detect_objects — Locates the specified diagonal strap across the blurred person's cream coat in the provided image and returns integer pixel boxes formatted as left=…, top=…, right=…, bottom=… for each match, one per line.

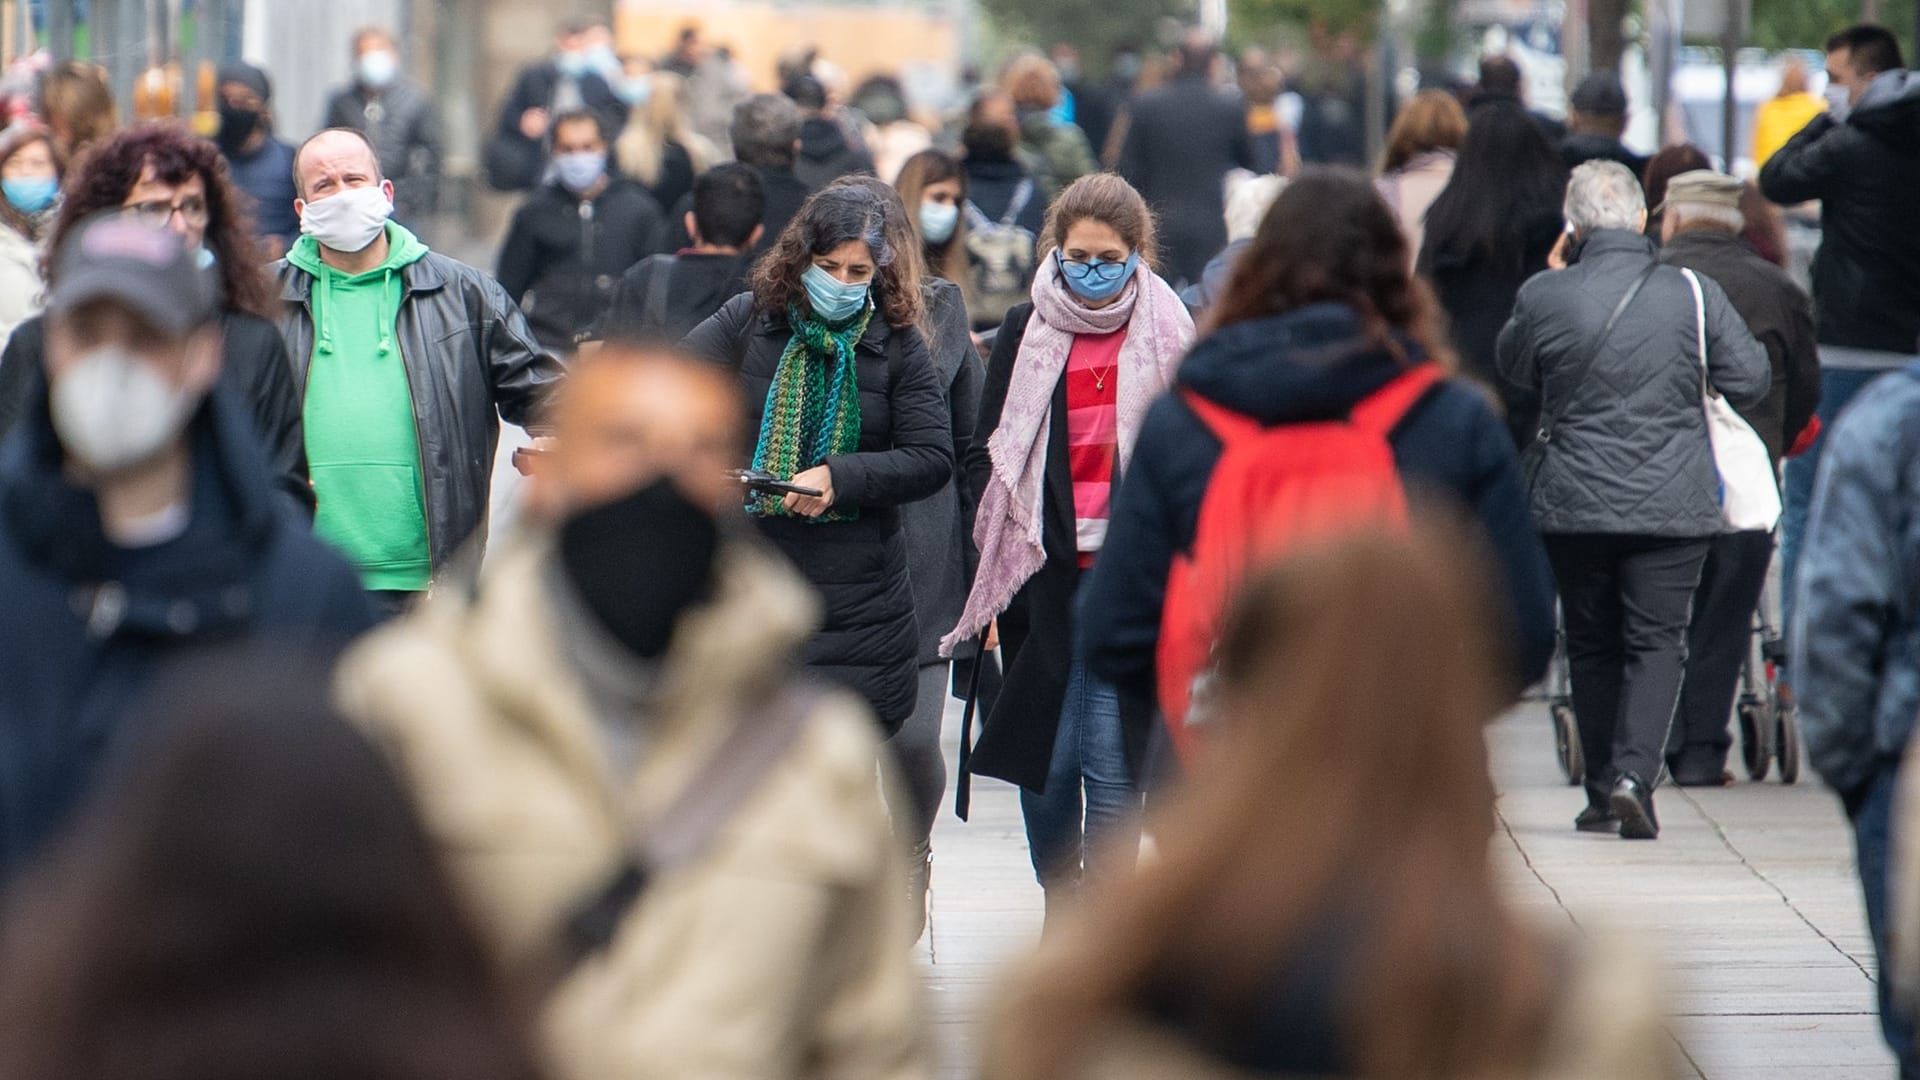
left=559, top=684, right=820, bottom=974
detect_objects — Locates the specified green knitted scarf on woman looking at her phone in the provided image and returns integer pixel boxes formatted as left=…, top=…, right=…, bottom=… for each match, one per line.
left=747, top=306, right=874, bottom=521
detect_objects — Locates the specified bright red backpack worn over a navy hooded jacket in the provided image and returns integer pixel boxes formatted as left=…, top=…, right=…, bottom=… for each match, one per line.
left=1158, top=363, right=1442, bottom=755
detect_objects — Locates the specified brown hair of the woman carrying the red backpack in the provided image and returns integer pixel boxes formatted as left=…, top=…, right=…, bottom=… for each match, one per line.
left=1210, top=165, right=1453, bottom=367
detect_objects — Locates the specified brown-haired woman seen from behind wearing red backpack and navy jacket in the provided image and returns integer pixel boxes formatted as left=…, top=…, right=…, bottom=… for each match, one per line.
left=1077, top=165, right=1553, bottom=757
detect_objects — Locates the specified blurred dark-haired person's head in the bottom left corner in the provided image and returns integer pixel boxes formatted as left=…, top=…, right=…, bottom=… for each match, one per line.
left=0, top=651, right=540, bottom=1080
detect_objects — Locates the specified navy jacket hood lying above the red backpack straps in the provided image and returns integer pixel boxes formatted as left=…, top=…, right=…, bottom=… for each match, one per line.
left=1179, top=304, right=1425, bottom=425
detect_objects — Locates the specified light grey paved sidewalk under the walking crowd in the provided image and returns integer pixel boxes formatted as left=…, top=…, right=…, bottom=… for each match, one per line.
left=920, top=703, right=1895, bottom=1080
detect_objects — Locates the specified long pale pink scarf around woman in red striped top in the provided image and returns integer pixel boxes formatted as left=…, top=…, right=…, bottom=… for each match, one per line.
left=941, top=258, right=1194, bottom=655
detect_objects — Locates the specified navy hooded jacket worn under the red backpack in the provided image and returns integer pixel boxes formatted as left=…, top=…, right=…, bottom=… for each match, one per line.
left=1075, top=304, right=1553, bottom=714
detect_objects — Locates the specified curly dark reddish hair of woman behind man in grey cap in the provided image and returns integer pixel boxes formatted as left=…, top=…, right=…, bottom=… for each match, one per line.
left=46, top=121, right=273, bottom=319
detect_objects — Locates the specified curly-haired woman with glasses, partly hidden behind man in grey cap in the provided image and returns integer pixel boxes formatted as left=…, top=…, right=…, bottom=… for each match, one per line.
left=0, top=121, right=313, bottom=517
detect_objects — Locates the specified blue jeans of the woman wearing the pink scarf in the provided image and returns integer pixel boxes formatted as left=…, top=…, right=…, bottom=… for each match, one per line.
left=1020, top=661, right=1140, bottom=888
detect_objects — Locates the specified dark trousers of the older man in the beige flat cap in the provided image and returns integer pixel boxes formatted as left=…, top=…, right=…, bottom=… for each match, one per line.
left=1667, top=532, right=1774, bottom=782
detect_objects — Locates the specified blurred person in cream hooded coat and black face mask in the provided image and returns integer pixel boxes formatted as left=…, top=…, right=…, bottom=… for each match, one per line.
left=340, top=346, right=925, bottom=1080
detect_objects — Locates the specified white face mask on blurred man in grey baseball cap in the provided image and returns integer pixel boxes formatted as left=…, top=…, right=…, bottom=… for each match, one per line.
left=50, top=346, right=196, bottom=473
